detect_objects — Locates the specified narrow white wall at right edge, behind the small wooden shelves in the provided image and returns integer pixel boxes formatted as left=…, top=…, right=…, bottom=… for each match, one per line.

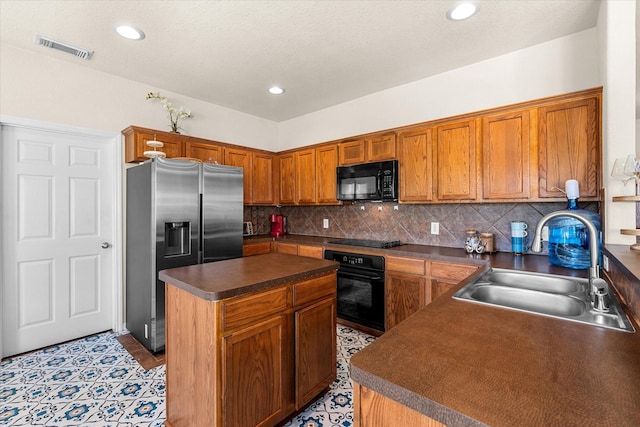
left=597, top=1, right=636, bottom=244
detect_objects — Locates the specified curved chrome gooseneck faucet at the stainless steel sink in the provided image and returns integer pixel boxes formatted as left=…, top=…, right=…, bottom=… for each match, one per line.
left=531, top=210, right=609, bottom=311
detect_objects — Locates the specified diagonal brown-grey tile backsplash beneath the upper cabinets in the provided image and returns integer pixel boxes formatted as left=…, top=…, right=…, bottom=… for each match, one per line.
left=244, top=202, right=599, bottom=252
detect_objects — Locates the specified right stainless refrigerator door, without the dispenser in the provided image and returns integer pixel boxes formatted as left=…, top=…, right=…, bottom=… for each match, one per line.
left=201, top=163, right=243, bottom=262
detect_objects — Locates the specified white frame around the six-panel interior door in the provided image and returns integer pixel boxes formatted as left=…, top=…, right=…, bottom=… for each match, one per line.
left=0, top=114, right=124, bottom=355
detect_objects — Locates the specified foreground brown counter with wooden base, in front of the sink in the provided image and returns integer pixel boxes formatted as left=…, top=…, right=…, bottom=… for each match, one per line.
left=351, top=275, right=640, bottom=427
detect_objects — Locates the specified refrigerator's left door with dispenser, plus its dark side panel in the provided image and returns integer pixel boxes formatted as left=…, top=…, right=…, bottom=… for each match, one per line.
left=126, top=159, right=200, bottom=352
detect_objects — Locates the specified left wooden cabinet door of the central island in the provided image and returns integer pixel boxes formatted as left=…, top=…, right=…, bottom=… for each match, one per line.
left=224, top=315, right=294, bottom=427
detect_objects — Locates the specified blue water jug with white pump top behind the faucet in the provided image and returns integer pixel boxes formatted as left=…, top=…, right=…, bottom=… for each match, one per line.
left=549, top=179, right=602, bottom=270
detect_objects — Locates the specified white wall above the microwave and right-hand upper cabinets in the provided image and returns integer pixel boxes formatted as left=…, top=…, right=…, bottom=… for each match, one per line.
left=279, top=29, right=601, bottom=149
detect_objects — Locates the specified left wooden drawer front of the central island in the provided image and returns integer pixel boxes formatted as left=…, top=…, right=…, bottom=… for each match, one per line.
left=222, top=286, right=287, bottom=330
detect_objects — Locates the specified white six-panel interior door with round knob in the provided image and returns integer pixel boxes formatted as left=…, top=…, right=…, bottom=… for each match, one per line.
left=1, top=126, right=115, bottom=356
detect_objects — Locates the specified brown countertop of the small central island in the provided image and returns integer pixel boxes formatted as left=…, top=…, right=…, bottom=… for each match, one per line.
left=159, top=253, right=338, bottom=301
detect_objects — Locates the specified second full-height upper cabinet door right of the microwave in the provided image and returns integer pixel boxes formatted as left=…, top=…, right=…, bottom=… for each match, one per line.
left=436, top=120, right=477, bottom=200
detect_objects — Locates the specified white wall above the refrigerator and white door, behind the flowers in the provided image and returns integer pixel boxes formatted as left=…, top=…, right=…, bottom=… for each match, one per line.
left=0, top=43, right=278, bottom=151
